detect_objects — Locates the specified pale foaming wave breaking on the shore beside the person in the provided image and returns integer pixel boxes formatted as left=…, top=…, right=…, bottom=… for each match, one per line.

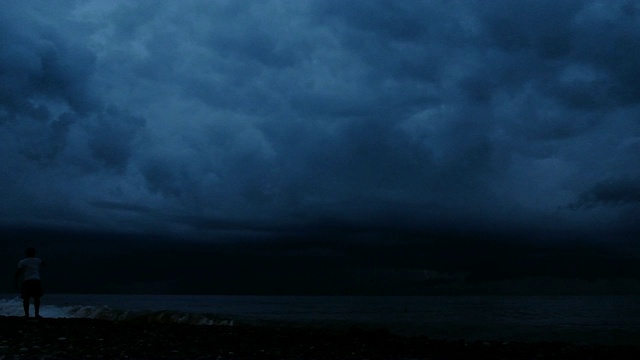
left=0, top=297, right=234, bottom=326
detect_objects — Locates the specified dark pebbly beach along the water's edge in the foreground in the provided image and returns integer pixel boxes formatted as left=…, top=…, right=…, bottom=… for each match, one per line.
left=0, top=317, right=640, bottom=360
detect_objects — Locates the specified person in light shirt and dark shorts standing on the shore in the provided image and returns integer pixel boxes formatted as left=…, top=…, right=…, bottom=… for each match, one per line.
left=15, top=247, right=44, bottom=318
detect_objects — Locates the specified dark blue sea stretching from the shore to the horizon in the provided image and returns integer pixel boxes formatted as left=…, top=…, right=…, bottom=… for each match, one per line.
left=0, top=294, right=640, bottom=346
